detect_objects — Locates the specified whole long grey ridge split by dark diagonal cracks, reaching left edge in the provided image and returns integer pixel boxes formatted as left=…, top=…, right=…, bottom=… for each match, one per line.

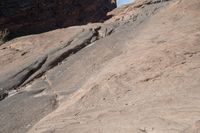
left=0, top=27, right=108, bottom=99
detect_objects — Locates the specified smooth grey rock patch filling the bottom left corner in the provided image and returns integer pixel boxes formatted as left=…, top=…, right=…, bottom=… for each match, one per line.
left=0, top=89, right=57, bottom=133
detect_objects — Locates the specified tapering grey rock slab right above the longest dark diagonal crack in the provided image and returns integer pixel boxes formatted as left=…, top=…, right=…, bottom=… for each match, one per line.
left=22, top=29, right=101, bottom=86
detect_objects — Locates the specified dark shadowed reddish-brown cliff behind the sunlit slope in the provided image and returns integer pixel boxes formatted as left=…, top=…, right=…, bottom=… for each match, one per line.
left=0, top=0, right=116, bottom=41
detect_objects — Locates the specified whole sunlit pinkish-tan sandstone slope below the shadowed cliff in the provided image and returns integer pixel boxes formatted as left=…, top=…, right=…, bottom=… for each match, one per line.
left=0, top=0, right=200, bottom=133
